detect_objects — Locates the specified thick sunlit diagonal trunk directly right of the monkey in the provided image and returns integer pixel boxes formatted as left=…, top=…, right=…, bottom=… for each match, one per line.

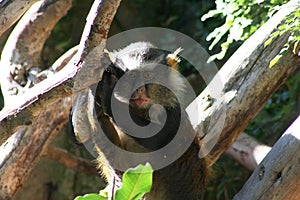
left=188, top=0, right=300, bottom=162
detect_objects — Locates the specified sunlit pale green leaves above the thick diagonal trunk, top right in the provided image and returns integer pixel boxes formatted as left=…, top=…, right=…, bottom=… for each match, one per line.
left=201, top=0, right=287, bottom=61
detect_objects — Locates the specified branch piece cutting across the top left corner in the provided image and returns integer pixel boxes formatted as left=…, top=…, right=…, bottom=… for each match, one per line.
left=0, top=0, right=38, bottom=36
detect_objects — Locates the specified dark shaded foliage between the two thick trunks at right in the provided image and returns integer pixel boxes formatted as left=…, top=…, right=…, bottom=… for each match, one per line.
left=246, top=72, right=300, bottom=146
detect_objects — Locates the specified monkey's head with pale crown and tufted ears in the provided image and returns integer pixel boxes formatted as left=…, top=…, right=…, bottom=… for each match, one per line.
left=107, top=42, right=186, bottom=119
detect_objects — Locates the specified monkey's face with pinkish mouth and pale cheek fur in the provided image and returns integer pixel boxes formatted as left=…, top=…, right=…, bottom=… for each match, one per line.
left=114, top=63, right=184, bottom=110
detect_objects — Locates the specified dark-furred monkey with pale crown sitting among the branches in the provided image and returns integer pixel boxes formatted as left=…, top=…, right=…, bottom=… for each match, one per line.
left=86, top=42, right=210, bottom=200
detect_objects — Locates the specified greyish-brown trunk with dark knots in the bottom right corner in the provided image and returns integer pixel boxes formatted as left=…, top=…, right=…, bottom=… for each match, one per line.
left=234, top=117, right=300, bottom=200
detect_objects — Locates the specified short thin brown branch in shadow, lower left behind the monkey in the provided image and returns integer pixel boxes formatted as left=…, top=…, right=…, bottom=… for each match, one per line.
left=44, top=145, right=98, bottom=174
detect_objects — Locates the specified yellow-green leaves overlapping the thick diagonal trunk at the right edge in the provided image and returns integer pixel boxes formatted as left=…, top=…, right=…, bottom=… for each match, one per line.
left=265, top=10, right=300, bottom=68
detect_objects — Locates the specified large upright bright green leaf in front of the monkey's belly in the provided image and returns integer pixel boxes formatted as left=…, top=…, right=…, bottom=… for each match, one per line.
left=114, top=163, right=153, bottom=200
